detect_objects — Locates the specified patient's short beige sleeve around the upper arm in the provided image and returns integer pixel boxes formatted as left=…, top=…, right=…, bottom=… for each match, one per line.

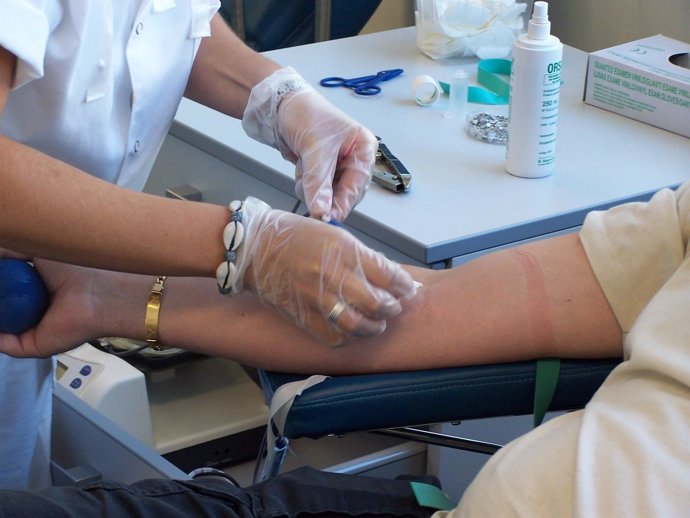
left=580, top=184, right=690, bottom=333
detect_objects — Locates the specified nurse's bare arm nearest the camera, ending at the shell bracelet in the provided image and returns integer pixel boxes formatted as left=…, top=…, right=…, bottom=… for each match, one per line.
left=0, top=47, right=228, bottom=277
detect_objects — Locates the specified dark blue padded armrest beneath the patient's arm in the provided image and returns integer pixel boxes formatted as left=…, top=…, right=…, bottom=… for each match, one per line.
left=259, top=358, right=621, bottom=438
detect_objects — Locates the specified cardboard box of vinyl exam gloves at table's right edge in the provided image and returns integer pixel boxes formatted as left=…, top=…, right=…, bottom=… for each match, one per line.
left=584, top=35, right=690, bottom=137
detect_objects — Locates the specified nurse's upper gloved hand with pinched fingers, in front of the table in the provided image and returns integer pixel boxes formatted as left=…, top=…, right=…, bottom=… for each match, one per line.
left=242, top=67, right=378, bottom=221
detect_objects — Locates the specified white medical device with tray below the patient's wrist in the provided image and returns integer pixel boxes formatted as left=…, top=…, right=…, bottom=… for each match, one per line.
left=56, top=344, right=268, bottom=471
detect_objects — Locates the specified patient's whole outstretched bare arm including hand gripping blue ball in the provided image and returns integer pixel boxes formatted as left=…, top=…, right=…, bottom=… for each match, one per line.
left=0, top=234, right=622, bottom=374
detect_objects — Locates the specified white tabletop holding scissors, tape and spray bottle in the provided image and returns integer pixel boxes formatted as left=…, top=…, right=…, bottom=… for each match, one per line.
left=172, top=27, right=690, bottom=263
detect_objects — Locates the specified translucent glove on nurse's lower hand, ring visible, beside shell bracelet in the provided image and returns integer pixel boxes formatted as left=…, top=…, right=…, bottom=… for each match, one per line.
left=226, top=198, right=416, bottom=345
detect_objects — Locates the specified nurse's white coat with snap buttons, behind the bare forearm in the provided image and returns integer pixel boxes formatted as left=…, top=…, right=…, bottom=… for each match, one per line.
left=0, top=0, right=220, bottom=487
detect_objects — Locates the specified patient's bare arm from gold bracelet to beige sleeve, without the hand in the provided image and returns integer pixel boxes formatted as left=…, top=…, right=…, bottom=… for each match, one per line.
left=155, top=234, right=622, bottom=374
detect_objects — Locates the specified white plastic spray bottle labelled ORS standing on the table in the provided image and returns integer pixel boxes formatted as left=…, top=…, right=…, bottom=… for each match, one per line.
left=505, top=1, right=563, bottom=178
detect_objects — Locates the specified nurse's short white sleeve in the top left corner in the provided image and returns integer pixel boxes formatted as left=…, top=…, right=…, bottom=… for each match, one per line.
left=0, top=0, right=50, bottom=88
